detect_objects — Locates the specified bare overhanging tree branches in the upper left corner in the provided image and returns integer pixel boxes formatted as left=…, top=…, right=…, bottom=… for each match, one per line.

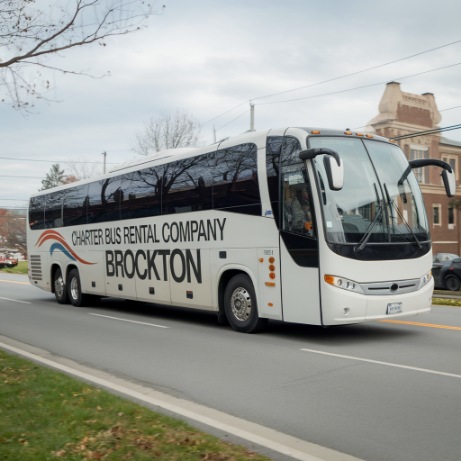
left=0, top=0, right=164, bottom=109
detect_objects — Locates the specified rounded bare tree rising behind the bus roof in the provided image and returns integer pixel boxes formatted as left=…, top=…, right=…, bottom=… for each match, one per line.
left=133, top=109, right=200, bottom=155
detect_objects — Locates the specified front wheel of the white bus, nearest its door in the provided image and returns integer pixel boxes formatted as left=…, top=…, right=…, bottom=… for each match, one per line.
left=224, top=274, right=267, bottom=333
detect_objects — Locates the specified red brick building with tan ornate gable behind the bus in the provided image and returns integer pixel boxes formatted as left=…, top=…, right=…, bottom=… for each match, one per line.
left=367, top=82, right=461, bottom=255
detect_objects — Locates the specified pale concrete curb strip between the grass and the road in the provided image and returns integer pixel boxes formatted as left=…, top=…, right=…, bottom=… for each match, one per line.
left=0, top=336, right=361, bottom=461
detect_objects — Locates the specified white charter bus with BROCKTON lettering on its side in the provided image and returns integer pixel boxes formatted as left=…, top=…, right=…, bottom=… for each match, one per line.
left=28, top=128, right=455, bottom=333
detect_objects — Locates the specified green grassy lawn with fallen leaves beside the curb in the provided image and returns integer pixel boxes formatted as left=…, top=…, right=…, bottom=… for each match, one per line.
left=0, top=350, right=268, bottom=461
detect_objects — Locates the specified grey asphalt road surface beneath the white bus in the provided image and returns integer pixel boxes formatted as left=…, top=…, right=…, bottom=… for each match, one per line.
left=0, top=273, right=461, bottom=461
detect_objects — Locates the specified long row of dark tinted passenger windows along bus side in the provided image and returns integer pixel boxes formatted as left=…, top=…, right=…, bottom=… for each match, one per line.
left=29, top=144, right=261, bottom=225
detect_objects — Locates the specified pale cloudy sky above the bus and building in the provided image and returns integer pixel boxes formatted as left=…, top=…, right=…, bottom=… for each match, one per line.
left=0, top=0, right=461, bottom=208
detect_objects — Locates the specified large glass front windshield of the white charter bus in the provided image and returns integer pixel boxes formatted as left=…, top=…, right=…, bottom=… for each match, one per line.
left=308, top=137, right=429, bottom=259
